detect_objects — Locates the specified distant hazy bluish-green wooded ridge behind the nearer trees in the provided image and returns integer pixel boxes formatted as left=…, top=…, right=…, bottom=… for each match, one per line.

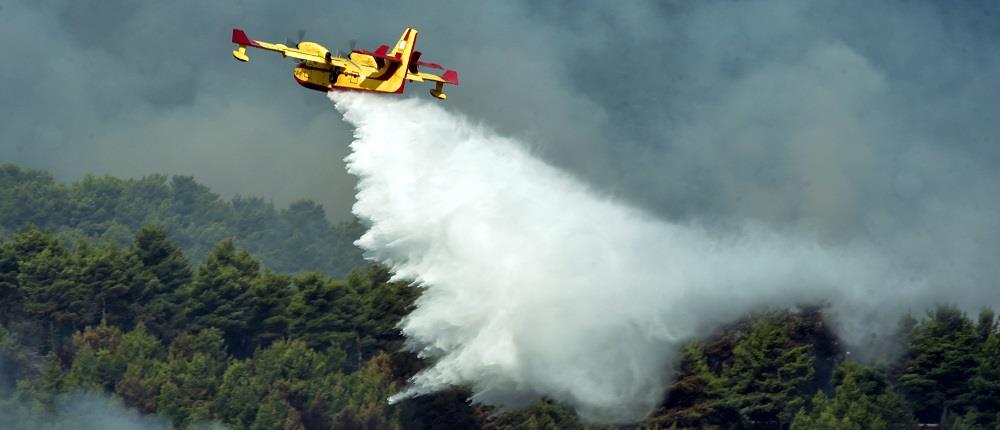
left=0, top=164, right=364, bottom=278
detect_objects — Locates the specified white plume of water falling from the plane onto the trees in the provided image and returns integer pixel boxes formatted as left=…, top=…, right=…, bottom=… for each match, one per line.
left=331, top=93, right=912, bottom=422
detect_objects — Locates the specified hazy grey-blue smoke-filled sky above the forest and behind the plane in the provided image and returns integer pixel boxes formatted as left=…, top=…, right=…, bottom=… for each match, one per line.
left=0, top=0, right=1000, bottom=302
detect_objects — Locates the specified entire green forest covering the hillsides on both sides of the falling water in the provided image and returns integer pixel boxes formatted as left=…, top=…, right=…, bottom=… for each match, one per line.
left=0, top=166, right=1000, bottom=430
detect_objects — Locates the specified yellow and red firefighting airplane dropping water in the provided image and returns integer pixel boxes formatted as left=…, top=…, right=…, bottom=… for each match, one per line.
left=233, top=28, right=458, bottom=100
